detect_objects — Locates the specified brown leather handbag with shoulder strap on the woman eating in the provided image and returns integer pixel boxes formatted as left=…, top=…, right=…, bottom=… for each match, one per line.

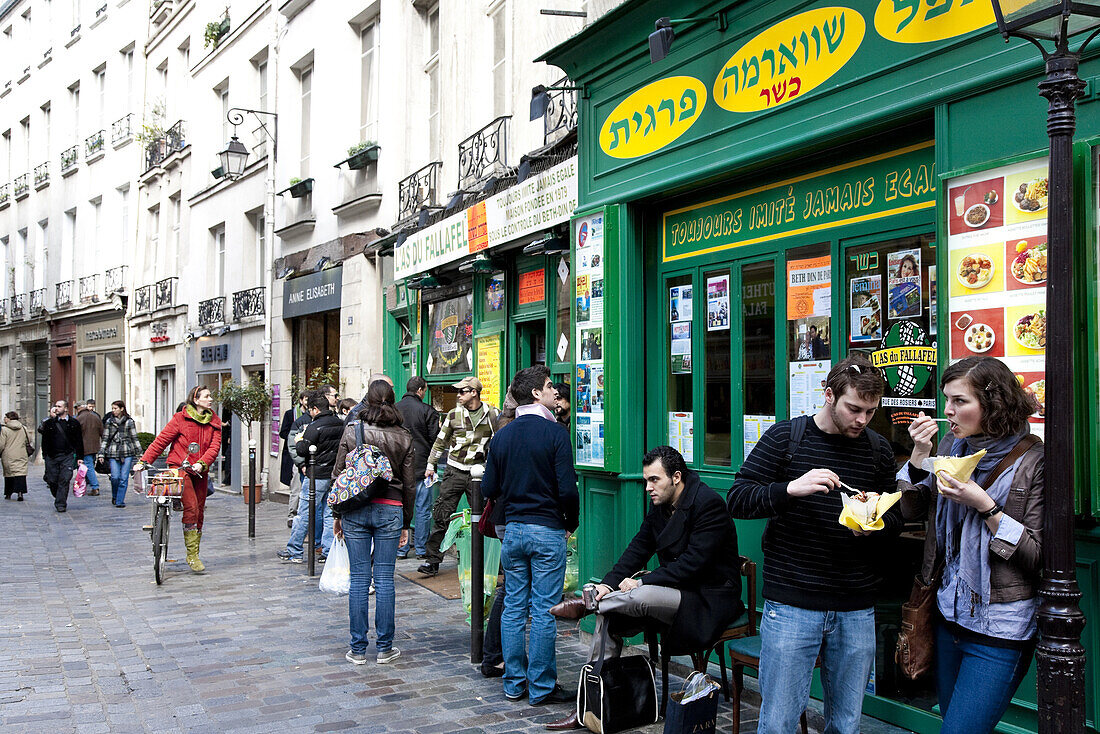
left=894, top=435, right=1038, bottom=680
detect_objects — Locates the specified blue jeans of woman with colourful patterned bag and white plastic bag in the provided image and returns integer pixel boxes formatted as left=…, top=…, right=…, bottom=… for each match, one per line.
left=340, top=504, right=403, bottom=655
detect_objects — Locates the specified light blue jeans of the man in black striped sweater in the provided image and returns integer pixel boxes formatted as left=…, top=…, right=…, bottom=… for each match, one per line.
left=757, top=601, right=875, bottom=734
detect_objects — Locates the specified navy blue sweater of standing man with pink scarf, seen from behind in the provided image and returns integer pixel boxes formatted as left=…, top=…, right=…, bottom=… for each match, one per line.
left=481, top=415, right=580, bottom=533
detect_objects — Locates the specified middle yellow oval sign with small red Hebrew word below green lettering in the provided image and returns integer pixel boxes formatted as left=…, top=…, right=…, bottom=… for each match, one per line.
left=714, top=8, right=867, bottom=112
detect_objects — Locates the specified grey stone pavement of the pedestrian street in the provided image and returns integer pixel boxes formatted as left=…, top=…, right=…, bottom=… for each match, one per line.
left=0, top=467, right=901, bottom=734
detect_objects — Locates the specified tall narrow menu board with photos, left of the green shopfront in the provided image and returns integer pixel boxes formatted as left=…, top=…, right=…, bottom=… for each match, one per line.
left=573, top=213, right=604, bottom=467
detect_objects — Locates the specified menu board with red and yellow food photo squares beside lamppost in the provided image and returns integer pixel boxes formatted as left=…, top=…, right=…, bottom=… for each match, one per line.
left=943, top=158, right=1048, bottom=436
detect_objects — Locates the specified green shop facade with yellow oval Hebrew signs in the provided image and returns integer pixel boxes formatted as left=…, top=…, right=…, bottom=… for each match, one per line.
left=541, top=0, right=1100, bottom=732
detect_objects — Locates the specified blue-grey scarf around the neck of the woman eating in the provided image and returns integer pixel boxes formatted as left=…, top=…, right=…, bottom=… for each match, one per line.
left=933, top=426, right=1029, bottom=604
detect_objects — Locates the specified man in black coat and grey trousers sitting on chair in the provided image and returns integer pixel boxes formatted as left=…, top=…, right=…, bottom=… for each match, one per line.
left=547, top=446, right=745, bottom=731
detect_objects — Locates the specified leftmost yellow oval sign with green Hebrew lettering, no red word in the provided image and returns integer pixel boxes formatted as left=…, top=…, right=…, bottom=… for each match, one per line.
left=600, top=76, right=706, bottom=158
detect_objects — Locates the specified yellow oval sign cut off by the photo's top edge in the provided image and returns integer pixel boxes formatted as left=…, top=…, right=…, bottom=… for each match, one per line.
left=875, top=0, right=997, bottom=43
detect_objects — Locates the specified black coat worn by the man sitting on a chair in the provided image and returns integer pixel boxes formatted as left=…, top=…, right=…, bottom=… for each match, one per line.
left=603, top=470, right=745, bottom=655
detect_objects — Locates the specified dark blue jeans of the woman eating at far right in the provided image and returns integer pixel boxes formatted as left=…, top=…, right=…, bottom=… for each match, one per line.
left=936, top=624, right=1035, bottom=734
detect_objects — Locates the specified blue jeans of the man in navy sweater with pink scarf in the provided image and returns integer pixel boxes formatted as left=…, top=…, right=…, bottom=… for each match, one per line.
left=501, top=523, right=565, bottom=703
